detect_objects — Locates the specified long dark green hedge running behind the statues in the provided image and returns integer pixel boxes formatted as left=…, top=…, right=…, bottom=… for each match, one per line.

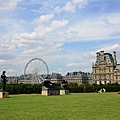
left=3, top=83, right=120, bottom=94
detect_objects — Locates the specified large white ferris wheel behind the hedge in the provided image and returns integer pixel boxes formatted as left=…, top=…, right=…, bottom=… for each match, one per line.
left=24, top=58, right=49, bottom=83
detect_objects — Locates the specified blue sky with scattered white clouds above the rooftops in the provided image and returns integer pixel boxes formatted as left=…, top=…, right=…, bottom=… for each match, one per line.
left=0, top=0, right=120, bottom=76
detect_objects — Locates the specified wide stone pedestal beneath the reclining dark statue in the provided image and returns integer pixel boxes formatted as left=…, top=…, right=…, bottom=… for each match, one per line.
left=42, top=89, right=60, bottom=96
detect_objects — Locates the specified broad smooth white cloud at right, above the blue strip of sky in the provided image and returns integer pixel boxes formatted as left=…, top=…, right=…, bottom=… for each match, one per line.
left=63, top=13, right=120, bottom=41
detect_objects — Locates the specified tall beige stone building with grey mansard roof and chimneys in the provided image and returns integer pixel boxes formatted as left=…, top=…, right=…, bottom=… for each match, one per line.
left=92, top=51, right=120, bottom=84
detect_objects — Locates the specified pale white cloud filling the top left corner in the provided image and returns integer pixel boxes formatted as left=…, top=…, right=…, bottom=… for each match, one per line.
left=0, top=0, right=22, bottom=11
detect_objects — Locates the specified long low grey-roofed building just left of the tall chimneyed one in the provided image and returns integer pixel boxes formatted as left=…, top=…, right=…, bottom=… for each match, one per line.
left=63, top=71, right=92, bottom=84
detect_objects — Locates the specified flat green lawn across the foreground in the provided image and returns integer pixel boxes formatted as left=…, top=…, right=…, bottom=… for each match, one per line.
left=0, top=93, right=120, bottom=120
